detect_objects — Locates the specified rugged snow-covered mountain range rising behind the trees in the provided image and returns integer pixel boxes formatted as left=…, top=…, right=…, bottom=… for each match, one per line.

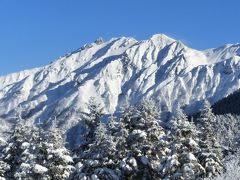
left=0, top=34, right=240, bottom=126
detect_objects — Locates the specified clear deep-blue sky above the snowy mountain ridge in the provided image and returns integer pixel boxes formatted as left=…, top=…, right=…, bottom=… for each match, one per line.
left=0, top=0, right=240, bottom=75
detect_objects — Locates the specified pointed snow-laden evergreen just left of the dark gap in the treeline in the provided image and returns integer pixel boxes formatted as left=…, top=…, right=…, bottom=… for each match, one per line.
left=37, top=119, right=75, bottom=180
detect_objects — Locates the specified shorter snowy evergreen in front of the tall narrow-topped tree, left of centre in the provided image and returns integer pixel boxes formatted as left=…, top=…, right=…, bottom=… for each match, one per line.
left=75, top=122, right=119, bottom=179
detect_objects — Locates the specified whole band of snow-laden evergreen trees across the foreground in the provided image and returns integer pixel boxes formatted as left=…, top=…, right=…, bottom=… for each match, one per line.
left=0, top=98, right=240, bottom=180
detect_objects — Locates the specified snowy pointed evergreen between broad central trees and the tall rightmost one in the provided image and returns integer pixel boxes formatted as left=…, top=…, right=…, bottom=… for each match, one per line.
left=160, top=108, right=205, bottom=179
